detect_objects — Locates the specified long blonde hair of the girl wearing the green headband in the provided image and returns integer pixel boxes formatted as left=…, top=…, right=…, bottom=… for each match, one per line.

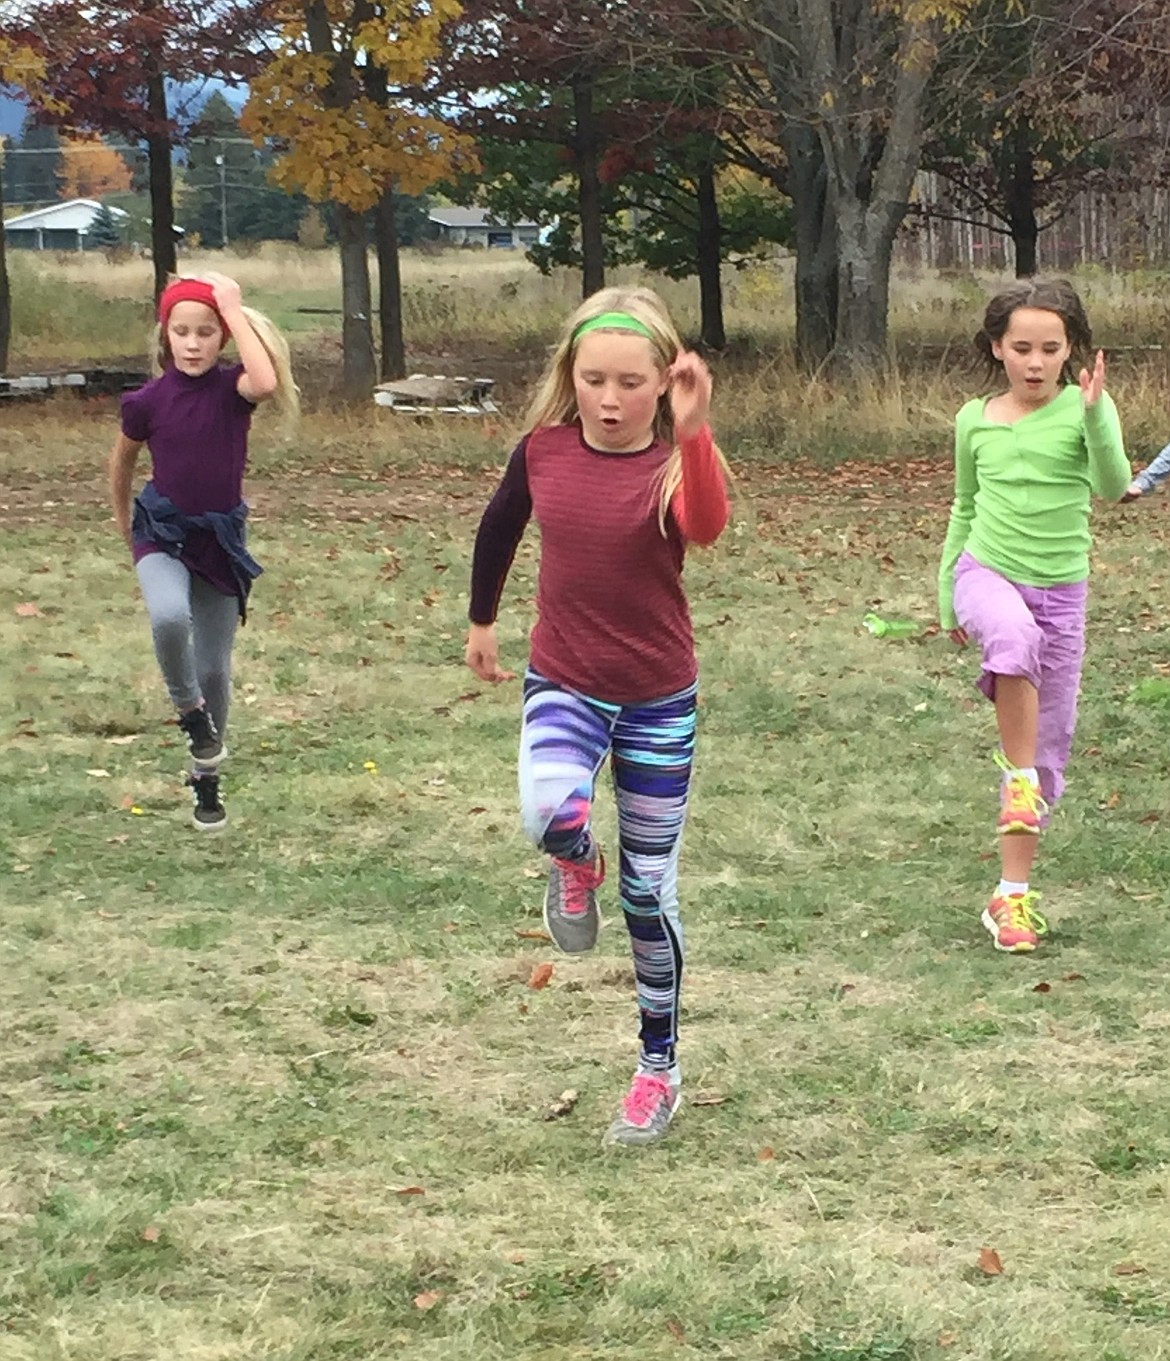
left=524, top=287, right=728, bottom=535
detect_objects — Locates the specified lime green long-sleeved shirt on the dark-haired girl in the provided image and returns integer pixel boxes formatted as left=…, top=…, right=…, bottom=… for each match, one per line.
left=939, top=384, right=1131, bottom=630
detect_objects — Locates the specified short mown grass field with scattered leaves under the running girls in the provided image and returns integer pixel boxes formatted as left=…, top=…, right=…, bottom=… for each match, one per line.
left=0, top=257, right=1170, bottom=1361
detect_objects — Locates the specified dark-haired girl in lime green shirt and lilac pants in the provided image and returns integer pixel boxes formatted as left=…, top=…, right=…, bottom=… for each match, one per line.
left=939, top=279, right=1131, bottom=953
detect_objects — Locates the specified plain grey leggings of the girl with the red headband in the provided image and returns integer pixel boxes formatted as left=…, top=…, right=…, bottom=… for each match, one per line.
left=137, top=553, right=239, bottom=736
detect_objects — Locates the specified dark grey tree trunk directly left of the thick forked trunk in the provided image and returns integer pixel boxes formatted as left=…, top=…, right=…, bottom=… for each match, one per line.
left=780, top=121, right=838, bottom=372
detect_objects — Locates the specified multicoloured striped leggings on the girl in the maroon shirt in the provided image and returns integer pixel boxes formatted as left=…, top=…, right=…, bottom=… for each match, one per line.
left=520, top=670, right=697, bottom=1071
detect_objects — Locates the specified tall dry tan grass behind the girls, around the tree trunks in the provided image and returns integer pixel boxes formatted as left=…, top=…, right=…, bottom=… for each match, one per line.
left=11, top=242, right=1170, bottom=465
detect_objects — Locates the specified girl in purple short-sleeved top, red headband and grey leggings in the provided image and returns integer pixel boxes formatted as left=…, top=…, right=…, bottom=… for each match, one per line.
left=110, top=274, right=297, bottom=832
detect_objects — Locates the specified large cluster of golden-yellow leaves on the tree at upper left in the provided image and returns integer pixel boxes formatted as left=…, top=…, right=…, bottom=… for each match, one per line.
left=241, top=0, right=475, bottom=212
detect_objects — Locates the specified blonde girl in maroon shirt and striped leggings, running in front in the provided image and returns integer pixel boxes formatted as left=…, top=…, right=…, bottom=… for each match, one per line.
left=467, top=289, right=728, bottom=1145
